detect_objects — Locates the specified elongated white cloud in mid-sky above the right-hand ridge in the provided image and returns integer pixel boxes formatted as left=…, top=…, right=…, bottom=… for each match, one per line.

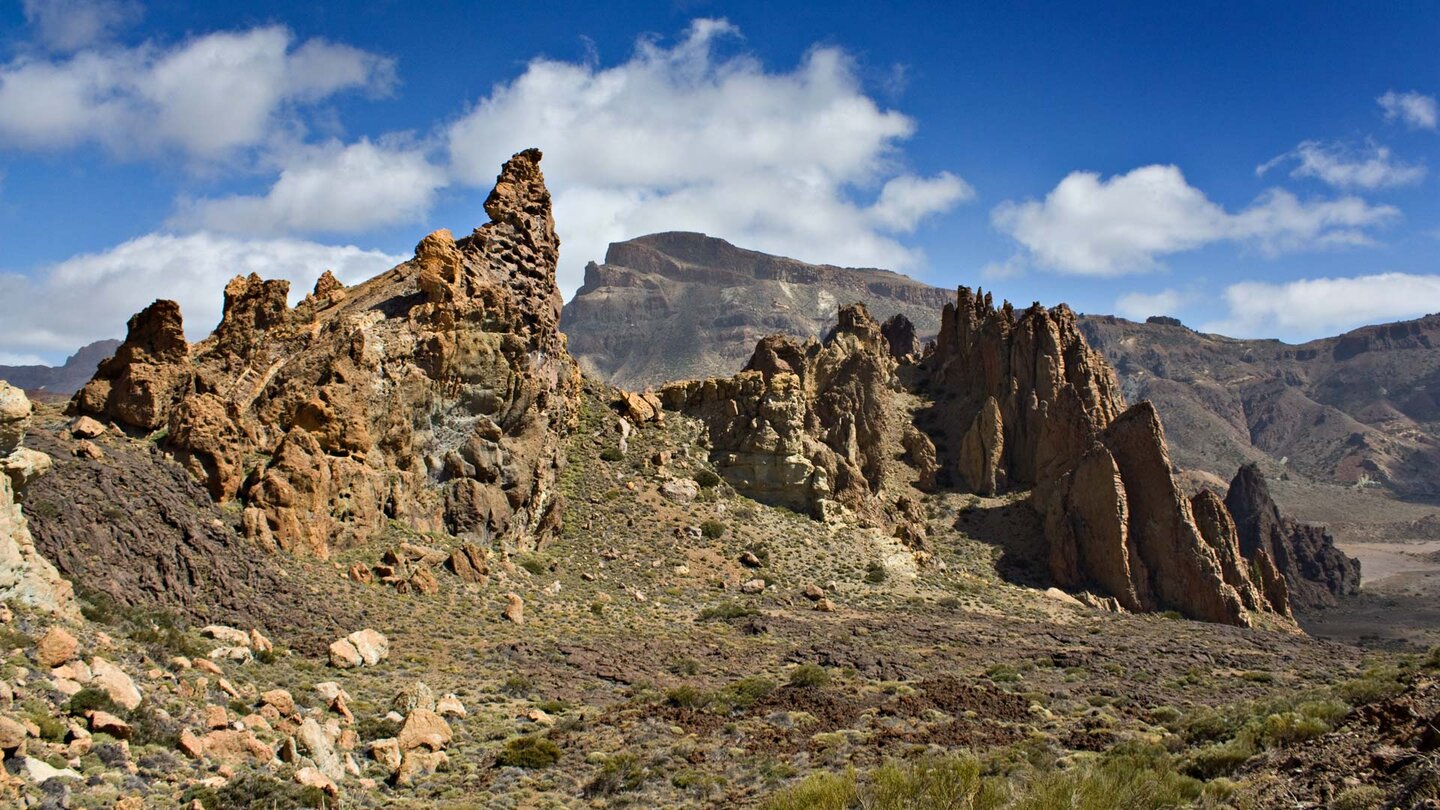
left=991, top=164, right=1400, bottom=275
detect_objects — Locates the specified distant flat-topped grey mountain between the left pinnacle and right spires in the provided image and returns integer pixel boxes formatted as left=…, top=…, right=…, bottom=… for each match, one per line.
left=563, top=232, right=950, bottom=391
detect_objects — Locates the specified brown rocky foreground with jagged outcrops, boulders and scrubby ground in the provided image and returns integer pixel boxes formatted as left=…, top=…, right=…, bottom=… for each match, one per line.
left=0, top=151, right=1440, bottom=810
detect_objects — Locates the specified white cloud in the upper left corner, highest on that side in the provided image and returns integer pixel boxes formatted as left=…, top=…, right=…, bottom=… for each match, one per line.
left=0, top=26, right=395, bottom=160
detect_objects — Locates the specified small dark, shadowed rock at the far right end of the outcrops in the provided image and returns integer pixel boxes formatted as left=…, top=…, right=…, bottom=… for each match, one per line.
left=1225, top=464, right=1359, bottom=608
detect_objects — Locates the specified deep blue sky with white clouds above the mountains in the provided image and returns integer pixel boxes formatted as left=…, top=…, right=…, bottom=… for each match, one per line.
left=0, top=0, right=1440, bottom=363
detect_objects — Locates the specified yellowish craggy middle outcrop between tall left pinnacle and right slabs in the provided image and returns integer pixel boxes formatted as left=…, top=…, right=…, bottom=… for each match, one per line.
left=660, top=304, right=913, bottom=539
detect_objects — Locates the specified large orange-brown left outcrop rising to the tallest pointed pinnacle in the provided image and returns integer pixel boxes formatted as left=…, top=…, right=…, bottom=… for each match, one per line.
left=72, top=150, right=579, bottom=556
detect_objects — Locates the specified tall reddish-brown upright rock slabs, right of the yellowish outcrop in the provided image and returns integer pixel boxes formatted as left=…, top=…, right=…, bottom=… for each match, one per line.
left=920, top=287, right=1284, bottom=624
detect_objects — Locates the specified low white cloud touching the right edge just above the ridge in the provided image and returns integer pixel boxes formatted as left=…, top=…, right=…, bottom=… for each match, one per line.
left=1202, top=272, right=1440, bottom=337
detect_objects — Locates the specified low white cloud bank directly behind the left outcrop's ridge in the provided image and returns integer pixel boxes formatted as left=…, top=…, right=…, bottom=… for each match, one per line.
left=0, top=233, right=409, bottom=360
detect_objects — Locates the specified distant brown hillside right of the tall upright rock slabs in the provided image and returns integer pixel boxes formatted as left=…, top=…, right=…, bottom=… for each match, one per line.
left=1081, top=309, right=1440, bottom=502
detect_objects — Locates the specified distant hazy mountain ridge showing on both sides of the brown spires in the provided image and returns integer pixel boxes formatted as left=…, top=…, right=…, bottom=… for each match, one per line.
left=562, top=233, right=1440, bottom=500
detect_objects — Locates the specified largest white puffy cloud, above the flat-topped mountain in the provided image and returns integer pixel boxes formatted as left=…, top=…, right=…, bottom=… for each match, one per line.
left=446, top=20, right=973, bottom=293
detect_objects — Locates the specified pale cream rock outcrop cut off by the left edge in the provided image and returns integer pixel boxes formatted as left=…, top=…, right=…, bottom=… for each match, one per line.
left=0, top=380, right=79, bottom=618
